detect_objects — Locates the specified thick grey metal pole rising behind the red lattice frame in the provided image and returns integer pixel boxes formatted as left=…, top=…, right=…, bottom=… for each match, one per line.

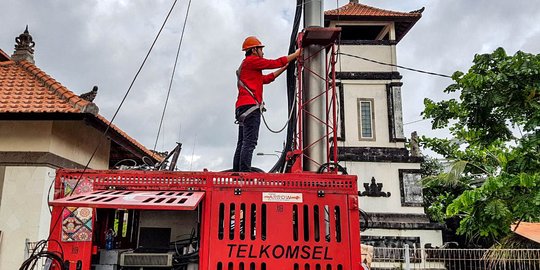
left=302, top=0, right=326, bottom=172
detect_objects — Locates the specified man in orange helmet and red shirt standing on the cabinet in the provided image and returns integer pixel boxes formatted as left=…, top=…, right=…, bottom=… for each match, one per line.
left=233, top=37, right=300, bottom=172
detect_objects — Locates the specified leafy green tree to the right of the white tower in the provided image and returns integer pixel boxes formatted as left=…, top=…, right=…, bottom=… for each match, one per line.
left=421, top=48, right=540, bottom=244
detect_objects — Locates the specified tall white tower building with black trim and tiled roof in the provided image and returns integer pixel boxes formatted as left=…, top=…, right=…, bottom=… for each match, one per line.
left=325, top=0, right=442, bottom=247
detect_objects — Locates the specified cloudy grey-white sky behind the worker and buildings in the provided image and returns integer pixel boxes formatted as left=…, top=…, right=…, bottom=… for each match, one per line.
left=0, top=0, right=540, bottom=171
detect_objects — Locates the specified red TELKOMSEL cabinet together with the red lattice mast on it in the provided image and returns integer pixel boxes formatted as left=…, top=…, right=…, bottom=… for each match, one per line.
left=45, top=25, right=362, bottom=270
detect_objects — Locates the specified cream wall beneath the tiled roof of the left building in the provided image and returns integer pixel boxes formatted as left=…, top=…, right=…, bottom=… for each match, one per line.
left=0, top=121, right=110, bottom=269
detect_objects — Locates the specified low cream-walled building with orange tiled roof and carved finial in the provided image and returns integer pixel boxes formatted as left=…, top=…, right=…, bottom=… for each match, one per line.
left=0, top=29, right=160, bottom=270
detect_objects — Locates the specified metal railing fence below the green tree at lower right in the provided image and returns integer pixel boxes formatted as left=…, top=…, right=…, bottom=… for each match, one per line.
left=370, top=245, right=540, bottom=270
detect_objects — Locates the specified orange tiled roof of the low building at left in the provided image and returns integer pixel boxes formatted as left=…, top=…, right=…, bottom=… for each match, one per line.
left=0, top=56, right=162, bottom=163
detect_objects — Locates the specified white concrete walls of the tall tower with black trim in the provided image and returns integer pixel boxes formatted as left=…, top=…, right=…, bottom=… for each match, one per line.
left=329, top=14, right=442, bottom=249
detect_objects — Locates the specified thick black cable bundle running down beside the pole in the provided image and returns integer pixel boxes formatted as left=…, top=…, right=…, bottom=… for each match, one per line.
left=270, top=0, right=304, bottom=173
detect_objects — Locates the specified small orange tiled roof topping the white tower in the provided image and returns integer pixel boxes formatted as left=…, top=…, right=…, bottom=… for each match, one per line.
left=324, top=3, right=423, bottom=19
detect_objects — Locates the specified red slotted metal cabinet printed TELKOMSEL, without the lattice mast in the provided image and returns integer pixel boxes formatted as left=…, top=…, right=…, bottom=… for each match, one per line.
left=45, top=170, right=361, bottom=270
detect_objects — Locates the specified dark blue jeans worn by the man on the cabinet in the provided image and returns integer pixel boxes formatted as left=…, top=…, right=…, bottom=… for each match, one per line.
left=233, top=105, right=261, bottom=172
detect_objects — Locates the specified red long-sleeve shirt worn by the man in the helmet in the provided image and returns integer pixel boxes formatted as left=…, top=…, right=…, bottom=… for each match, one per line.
left=236, top=55, right=287, bottom=108
